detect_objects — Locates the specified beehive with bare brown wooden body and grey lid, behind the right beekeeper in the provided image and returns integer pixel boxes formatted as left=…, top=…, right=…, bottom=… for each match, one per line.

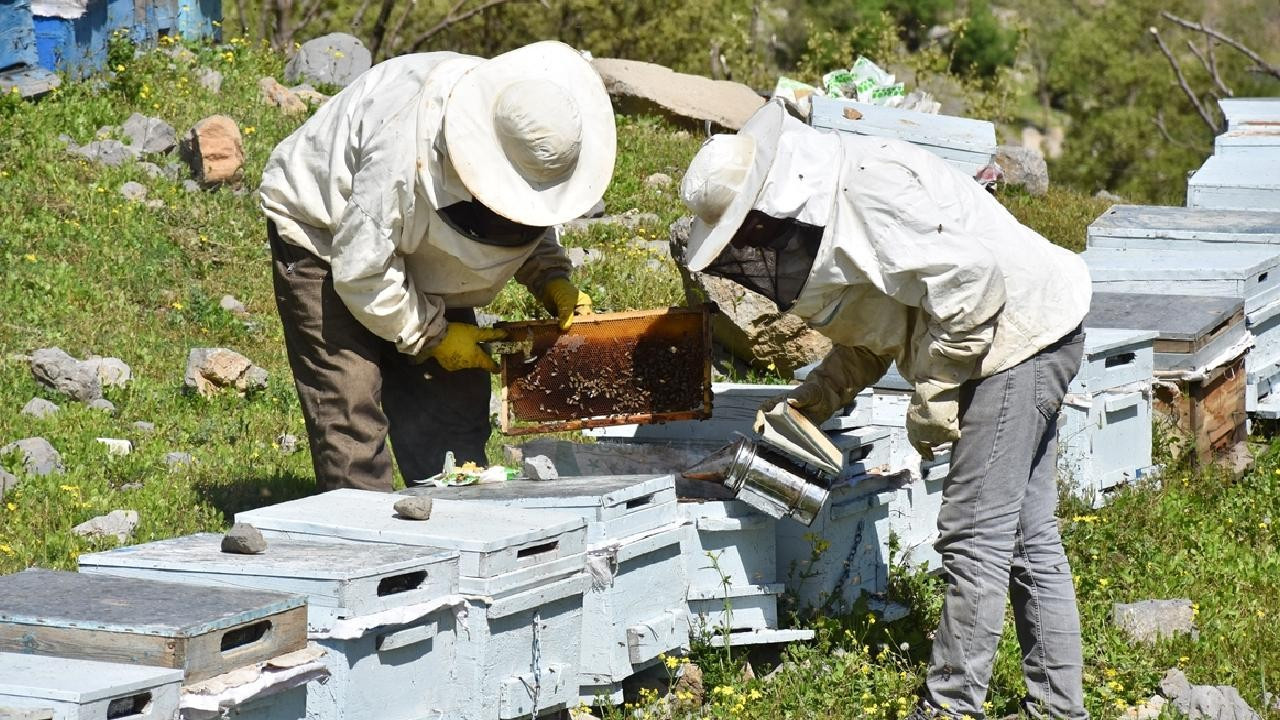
left=1084, top=292, right=1252, bottom=460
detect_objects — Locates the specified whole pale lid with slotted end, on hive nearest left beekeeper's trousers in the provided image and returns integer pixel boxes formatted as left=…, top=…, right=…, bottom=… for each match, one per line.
left=236, top=489, right=586, bottom=596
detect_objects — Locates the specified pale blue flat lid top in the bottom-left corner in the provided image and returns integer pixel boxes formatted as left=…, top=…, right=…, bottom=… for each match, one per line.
left=0, top=652, right=183, bottom=702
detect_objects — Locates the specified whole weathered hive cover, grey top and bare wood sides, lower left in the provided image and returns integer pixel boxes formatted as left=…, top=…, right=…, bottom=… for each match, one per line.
left=0, top=570, right=307, bottom=683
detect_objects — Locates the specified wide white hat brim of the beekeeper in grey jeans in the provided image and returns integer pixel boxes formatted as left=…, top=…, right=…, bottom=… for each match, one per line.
left=685, top=100, right=787, bottom=273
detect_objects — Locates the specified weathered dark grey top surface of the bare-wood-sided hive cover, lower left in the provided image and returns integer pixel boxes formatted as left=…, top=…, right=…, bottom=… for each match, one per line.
left=0, top=569, right=305, bottom=638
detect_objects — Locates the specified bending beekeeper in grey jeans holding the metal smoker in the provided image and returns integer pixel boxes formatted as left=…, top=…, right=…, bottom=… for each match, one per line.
left=681, top=101, right=1091, bottom=719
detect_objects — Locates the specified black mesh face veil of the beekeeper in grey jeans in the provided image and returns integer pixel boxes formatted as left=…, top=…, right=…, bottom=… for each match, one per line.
left=703, top=210, right=823, bottom=311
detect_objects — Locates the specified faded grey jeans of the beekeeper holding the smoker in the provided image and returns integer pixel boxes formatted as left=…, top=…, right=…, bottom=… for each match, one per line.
left=922, top=331, right=1088, bottom=720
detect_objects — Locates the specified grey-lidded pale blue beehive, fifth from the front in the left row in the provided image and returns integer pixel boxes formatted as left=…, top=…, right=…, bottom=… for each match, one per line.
left=402, top=475, right=689, bottom=702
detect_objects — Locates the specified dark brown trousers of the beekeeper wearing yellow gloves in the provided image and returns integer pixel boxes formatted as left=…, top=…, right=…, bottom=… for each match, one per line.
left=268, top=223, right=490, bottom=491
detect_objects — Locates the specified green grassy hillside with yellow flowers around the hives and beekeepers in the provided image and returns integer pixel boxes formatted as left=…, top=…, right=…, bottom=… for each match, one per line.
left=0, top=37, right=1280, bottom=720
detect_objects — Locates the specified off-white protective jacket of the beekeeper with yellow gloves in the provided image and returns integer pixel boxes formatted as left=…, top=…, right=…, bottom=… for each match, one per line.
left=260, top=53, right=571, bottom=355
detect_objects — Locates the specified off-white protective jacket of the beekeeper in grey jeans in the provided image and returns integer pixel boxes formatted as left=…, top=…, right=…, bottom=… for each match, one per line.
left=758, top=122, right=1091, bottom=407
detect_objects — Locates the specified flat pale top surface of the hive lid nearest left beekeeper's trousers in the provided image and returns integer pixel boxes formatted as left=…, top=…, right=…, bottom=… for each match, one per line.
left=236, top=489, right=586, bottom=553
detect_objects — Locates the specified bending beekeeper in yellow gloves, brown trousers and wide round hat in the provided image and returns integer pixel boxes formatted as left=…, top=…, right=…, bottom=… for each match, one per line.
left=260, top=42, right=616, bottom=491
